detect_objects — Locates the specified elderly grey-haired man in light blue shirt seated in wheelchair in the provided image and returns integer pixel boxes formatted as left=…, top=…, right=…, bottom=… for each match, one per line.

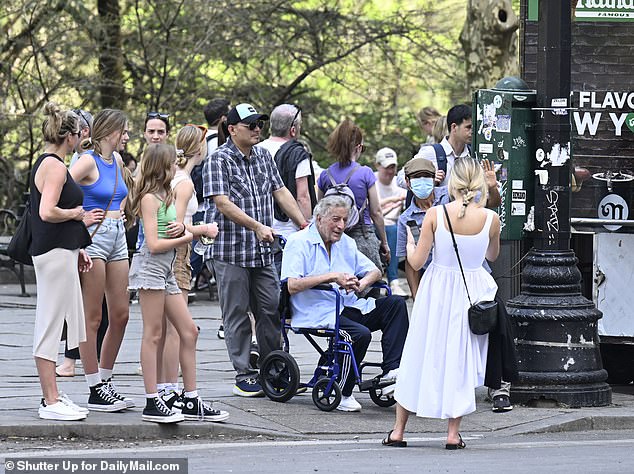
left=281, top=196, right=409, bottom=412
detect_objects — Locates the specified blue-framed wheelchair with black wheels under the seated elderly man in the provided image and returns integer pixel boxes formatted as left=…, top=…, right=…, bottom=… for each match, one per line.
left=260, top=282, right=396, bottom=411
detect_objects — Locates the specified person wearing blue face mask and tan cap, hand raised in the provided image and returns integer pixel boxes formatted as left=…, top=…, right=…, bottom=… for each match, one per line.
left=396, top=158, right=449, bottom=298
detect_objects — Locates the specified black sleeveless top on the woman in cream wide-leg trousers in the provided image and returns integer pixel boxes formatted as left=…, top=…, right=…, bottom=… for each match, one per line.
left=29, top=153, right=91, bottom=256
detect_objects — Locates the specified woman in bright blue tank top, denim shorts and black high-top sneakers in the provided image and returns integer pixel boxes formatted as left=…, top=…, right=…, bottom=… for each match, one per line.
left=70, top=109, right=134, bottom=412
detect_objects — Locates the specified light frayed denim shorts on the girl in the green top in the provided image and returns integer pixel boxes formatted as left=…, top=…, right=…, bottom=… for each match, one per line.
left=128, top=244, right=181, bottom=295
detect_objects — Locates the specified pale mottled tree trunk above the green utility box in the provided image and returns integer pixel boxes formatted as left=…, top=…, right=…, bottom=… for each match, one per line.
left=460, top=0, right=519, bottom=91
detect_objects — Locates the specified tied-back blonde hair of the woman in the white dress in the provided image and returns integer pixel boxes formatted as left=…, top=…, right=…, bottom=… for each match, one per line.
left=448, top=156, right=489, bottom=218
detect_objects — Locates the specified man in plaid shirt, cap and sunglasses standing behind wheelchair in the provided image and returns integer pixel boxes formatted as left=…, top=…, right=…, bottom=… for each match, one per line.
left=203, top=104, right=308, bottom=397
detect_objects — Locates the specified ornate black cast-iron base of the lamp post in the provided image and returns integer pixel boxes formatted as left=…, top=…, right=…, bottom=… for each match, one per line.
left=506, top=250, right=612, bottom=407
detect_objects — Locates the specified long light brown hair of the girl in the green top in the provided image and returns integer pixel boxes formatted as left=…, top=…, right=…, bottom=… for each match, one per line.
left=132, top=143, right=176, bottom=217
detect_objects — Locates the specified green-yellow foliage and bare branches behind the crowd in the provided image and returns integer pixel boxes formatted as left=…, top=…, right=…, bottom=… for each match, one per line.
left=0, top=0, right=468, bottom=207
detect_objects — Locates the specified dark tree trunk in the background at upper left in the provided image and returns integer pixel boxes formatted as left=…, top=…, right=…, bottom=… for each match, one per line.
left=97, top=0, right=126, bottom=109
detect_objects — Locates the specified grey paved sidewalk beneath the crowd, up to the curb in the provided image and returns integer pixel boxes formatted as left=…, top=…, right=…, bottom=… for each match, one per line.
left=0, top=284, right=634, bottom=440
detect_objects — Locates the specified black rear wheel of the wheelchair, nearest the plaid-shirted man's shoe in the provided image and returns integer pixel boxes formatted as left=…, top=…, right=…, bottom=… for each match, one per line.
left=260, top=351, right=299, bottom=402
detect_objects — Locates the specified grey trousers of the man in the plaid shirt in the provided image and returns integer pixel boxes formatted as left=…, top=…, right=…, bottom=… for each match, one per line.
left=213, top=259, right=281, bottom=382
